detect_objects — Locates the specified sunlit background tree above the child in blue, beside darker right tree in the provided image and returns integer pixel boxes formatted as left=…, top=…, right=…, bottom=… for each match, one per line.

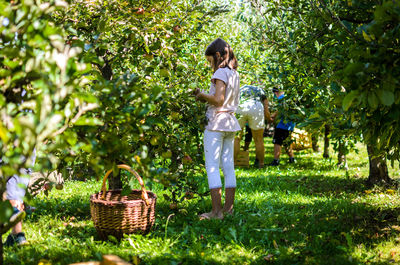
left=238, top=1, right=351, bottom=164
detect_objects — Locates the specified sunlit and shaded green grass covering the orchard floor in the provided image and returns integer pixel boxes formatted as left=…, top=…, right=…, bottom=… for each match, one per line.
left=3, top=138, right=400, bottom=265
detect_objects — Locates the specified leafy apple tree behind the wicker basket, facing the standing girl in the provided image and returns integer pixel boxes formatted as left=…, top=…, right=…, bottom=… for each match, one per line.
left=52, top=0, right=234, bottom=200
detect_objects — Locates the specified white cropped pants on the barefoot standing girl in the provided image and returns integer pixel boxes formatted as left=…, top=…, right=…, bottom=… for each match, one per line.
left=204, top=130, right=236, bottom=189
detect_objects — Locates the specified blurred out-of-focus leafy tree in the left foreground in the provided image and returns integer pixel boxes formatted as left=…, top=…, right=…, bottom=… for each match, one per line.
left=0, top=0, right=97, bottom=261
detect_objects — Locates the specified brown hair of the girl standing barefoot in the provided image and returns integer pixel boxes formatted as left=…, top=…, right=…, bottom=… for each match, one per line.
left=205, top=38, right=238, bottom=71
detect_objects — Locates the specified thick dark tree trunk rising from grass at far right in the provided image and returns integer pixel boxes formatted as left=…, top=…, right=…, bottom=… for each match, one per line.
left=367, top=144, right=392, bottom=185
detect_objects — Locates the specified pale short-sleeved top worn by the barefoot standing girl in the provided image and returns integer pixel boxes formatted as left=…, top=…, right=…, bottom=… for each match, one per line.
left=206, top=67, right=241, bottom=132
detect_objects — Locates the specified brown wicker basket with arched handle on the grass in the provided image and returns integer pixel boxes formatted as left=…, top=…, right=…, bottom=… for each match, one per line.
left=90, top=165, right=157, bottom=239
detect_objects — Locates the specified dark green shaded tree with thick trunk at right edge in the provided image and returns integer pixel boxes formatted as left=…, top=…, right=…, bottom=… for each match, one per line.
left=244, top=1, right=400, bottom=183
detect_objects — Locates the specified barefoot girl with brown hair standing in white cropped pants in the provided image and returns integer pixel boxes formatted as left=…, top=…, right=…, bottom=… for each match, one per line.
left=195, top=38, right=241, bottom=219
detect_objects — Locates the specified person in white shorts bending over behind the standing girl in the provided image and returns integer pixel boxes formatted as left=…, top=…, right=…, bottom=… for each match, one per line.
left=235, top=85, right=271, bottom=168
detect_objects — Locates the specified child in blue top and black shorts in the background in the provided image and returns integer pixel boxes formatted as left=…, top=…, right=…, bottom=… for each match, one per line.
left=269, top=87, right=295, bottom=166
